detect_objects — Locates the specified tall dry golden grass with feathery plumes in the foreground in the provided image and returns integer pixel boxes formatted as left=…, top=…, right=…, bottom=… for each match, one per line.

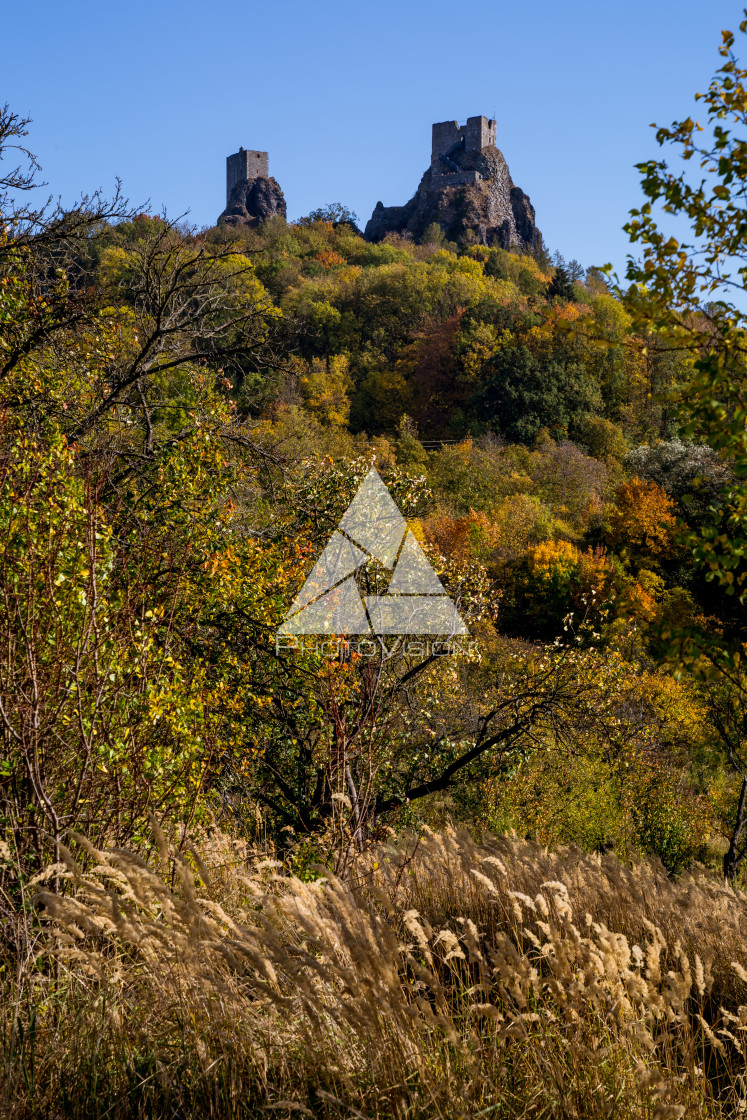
left=0, top=831, right=747, bottom=1120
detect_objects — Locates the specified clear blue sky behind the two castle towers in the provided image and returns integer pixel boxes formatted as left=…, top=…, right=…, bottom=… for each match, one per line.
left=0, top=0, right=747, bottom=271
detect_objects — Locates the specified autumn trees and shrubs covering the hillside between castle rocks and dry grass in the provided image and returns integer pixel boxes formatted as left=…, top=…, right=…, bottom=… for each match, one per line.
left=2, top=172, right=736, bottom=871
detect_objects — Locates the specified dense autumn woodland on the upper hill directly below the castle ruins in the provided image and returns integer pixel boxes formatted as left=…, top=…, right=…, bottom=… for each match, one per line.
left=208, top=210, right=688, bottom=441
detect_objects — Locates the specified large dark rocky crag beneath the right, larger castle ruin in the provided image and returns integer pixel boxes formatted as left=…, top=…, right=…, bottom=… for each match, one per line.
left=365, top=148, right=542, bottom=250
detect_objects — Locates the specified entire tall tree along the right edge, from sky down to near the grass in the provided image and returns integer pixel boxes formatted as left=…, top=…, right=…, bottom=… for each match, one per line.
left=625, top=11, right=747, bottom=878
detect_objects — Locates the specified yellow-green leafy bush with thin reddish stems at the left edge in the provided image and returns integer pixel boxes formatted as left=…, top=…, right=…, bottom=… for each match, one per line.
left=0, top=429, right=231, bottom=859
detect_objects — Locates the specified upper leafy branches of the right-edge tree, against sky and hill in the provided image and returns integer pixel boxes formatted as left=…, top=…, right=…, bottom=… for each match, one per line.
left=626, top=8, right=747, bottom=599
